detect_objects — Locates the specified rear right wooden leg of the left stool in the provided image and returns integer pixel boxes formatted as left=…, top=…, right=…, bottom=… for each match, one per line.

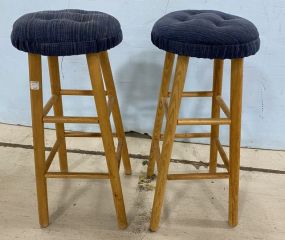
left=99, top=51, right=132, bottom=175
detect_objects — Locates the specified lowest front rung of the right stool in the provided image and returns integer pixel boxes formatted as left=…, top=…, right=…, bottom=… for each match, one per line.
left=167, top=173, right=230, bottom=180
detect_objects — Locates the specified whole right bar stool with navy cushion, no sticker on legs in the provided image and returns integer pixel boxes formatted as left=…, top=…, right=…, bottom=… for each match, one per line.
left=147, top=10, right=260, bottom=231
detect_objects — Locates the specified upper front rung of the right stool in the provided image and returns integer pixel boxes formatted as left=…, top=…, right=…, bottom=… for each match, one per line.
left=177, top=118, right=231, bottom=125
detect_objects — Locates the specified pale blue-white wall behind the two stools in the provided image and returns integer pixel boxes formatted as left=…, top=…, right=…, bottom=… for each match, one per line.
left=0, top=0, right=285, bottom=149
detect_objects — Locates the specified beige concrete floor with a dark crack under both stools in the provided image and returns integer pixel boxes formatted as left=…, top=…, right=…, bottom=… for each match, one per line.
left=0, top=124, right=285, bottom=240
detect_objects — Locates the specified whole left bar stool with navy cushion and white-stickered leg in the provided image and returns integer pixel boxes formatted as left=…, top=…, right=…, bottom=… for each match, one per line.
left=11, top=10, right=131, bottom=229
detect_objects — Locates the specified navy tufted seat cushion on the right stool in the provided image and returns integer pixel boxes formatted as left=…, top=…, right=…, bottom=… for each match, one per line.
left=151, top=10, right=260, bottom=59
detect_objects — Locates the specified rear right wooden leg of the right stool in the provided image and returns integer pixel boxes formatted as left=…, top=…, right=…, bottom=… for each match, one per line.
left=209, top=59, right=224, bottom=173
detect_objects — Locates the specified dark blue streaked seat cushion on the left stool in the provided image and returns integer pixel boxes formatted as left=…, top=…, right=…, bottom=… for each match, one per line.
left=11, top=9, right=123, bottom=56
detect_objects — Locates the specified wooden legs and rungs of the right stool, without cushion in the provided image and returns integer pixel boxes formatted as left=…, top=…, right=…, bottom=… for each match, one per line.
left=147, top=52, right=243, bottom=231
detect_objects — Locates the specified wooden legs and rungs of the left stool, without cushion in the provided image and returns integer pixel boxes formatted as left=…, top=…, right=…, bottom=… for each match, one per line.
left=29, top=51, right=131, bottom=229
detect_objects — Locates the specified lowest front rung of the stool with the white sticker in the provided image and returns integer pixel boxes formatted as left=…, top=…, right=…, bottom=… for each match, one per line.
left=45, top=172, right=110, bottom=179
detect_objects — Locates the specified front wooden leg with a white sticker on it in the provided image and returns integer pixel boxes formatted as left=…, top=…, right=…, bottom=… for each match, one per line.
left=29, top=53, right=49, bottom=227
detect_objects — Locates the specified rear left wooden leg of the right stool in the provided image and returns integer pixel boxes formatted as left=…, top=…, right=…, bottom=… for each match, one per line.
left=147, top=52, right=175, bottom=177
